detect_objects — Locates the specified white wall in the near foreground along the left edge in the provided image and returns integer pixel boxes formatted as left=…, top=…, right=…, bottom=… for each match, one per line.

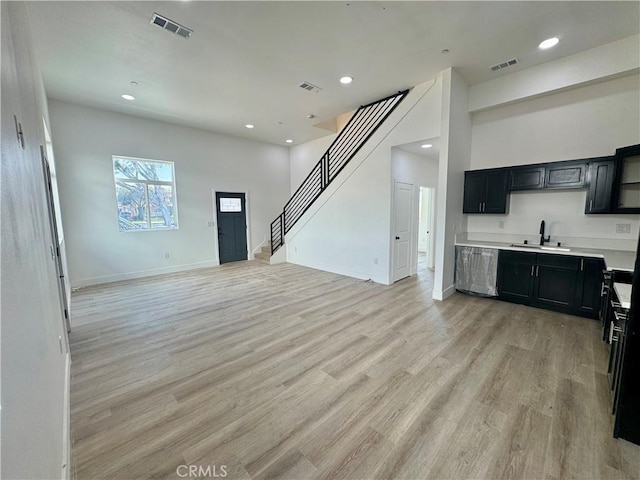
left=0, top=2, right=69, bottom=479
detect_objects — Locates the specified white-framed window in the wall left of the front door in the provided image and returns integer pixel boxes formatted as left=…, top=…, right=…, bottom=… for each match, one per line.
left=113, top=155, right=178, bottom=232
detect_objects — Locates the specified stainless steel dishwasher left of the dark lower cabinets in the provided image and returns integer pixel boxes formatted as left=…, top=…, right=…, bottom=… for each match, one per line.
left=455, top=246, right=498, bottom=297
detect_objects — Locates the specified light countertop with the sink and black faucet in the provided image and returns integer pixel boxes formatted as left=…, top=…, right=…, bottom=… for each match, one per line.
left=456, top=240, right=636, bottom=272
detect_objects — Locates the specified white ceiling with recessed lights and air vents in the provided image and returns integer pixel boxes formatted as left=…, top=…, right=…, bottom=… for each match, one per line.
left=28, top=1, right=640, bottom=145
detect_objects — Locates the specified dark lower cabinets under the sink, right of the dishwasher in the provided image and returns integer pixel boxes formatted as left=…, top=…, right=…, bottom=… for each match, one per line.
left=498, top=250, right=604, bottom=318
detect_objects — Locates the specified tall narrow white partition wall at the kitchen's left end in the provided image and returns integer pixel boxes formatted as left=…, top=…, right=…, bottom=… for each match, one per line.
left=433, top=68, right=471, bottom=300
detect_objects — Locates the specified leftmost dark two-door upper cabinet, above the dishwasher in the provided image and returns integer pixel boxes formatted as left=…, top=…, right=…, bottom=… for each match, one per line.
left=462, top=169, right=507, bottom=213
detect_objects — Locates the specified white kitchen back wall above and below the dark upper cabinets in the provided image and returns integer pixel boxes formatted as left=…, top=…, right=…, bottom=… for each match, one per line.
left=467, top=75, right=640, bottom=250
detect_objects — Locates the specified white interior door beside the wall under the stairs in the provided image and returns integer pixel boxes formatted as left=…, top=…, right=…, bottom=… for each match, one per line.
left=393, top=181, right=417, bottom=282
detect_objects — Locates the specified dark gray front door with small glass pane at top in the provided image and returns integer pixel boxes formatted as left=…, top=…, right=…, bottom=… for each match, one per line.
left=216, top=192, right=247, bottom=263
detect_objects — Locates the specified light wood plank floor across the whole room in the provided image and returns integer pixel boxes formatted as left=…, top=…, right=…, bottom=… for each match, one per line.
left=71, top=261, right=640, bottom=480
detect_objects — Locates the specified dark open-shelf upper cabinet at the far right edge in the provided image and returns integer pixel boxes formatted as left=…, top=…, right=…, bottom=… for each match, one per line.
left=612, top=145, right=640, bottom=213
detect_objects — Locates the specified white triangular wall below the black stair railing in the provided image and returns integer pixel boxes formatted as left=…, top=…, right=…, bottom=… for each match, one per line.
left=285, top=78, right=442, bottom=284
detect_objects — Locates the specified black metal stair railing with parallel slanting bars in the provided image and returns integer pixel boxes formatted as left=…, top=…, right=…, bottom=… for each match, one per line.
left=268, top=90, right=409, bottom=256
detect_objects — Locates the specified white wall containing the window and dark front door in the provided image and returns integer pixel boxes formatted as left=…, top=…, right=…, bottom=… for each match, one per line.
left=49, top=100, right=290, bottom=286
